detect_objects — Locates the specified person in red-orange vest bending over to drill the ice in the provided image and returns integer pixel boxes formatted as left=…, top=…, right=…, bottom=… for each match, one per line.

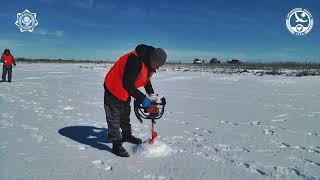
left=103, top=44, right=167, bottom=157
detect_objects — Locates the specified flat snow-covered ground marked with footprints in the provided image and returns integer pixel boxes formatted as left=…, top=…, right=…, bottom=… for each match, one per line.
left=0, top=64, right=320, bottom=180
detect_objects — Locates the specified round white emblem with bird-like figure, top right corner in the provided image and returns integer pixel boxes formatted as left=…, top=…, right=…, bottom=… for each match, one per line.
left=286, top=8, right=313, bottom=36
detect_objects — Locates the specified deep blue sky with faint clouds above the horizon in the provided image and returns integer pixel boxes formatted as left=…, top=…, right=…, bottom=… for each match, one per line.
left=0, top=0, right=320, bottom=62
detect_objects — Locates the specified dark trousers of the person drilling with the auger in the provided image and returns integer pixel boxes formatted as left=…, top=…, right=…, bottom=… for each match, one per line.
left=104, top=88, right=131, bottom=141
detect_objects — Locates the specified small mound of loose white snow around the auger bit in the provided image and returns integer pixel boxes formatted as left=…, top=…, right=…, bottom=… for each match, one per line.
left=132, top=140, right=174, bottom=158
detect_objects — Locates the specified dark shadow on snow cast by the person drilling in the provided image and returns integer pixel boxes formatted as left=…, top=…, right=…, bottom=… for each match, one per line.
left=58, top=126, right=111, bottom=152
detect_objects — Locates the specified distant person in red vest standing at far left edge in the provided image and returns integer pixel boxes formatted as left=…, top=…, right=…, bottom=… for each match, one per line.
left=1, top=49, right=16, bottom=82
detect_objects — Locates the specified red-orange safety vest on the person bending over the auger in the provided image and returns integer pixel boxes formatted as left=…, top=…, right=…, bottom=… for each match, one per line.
left=104, top=51, right=154, bottom=101
